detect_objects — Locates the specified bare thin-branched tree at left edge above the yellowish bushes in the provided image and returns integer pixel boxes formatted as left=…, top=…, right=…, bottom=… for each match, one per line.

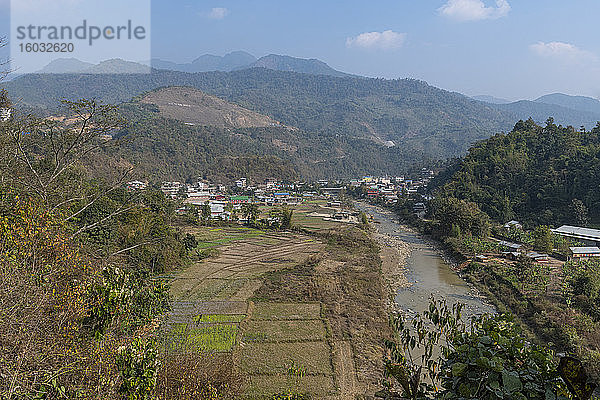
left=2, top=100, right=135, bottom=237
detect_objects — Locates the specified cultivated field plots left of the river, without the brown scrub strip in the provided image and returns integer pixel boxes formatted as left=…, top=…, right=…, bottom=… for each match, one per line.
left=163, top=202, right=386, bottom=399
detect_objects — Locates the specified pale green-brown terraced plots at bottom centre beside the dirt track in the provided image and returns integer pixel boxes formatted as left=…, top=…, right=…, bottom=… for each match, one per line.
left=240, top=302, right=336, bottom=397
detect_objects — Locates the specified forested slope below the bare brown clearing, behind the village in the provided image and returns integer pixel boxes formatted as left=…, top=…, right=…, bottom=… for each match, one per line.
left=106, top=99, right=412, bottom=183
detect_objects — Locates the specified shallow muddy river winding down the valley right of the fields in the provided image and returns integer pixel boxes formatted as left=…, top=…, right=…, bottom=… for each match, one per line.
left=358, top=203, right=495, bottom=318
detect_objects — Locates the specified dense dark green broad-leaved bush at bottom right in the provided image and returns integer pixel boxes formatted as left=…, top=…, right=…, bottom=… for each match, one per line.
left=437, top=315, right=571, bottom=400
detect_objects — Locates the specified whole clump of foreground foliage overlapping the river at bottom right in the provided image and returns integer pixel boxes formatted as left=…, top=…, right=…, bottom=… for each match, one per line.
left=377, top=300, right=573, bottom=400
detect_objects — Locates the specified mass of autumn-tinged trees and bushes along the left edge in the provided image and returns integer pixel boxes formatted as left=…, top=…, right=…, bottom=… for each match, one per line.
left=0, top=101, right=238, bottom=399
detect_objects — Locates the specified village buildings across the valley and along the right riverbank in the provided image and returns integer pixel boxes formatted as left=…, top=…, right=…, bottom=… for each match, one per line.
left=127, top=168, right=600, bottom=265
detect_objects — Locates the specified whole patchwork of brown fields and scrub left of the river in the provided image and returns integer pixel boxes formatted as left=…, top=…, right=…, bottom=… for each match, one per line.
left=168, top=208, right=387, bottom=399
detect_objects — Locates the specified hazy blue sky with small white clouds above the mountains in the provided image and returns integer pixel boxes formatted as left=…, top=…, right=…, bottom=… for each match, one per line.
left=0, top=0, right=600, bottom=100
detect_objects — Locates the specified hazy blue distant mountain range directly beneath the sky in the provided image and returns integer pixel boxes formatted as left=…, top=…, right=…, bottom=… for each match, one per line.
left=5, top=68, right=600, bottom=163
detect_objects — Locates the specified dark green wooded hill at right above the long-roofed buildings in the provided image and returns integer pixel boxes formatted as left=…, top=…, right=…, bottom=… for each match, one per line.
left=434, top=119, right=600, bottom=226
